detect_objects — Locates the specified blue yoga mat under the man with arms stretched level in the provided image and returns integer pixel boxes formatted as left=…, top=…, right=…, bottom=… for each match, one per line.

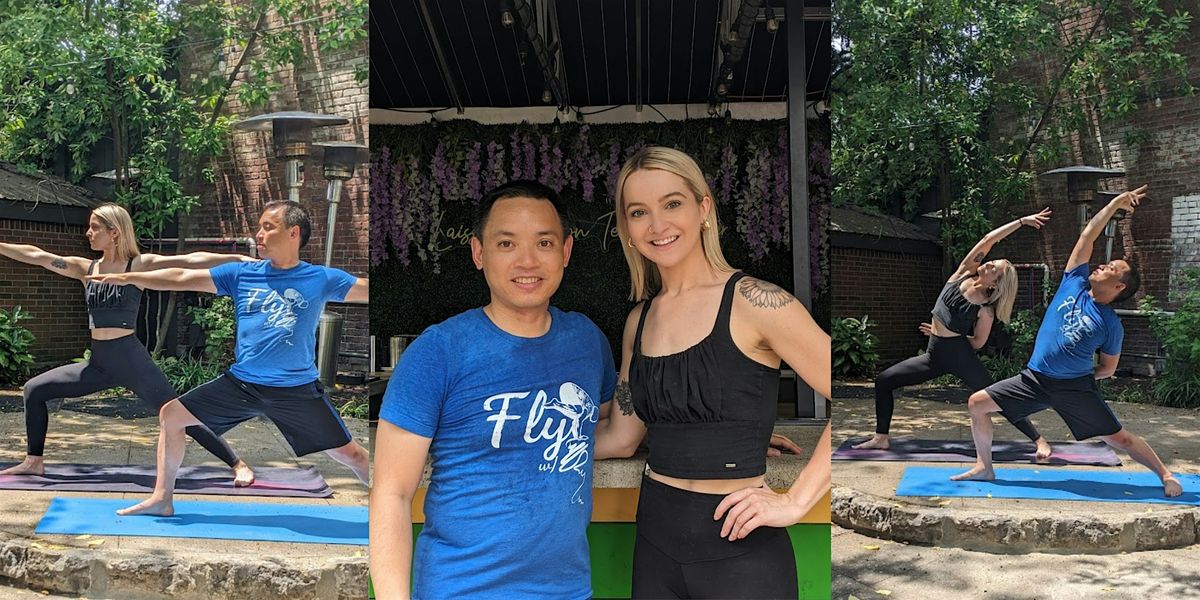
left=36, top=498, right=367, bottom=546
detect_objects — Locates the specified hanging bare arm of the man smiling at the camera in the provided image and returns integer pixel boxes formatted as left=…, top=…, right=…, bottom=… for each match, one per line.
left=370, top=420, right=432, bottom=599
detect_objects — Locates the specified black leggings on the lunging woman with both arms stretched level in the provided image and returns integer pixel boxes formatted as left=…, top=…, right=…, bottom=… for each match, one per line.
left=25, top=335, right=238, bottom=467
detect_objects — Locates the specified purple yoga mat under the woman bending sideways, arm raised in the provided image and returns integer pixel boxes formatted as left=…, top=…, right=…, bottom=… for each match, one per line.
left=833, top=438, right=1121, bottom=467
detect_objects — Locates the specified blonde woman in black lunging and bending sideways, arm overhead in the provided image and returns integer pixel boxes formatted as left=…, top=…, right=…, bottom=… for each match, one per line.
left=854, top=209, right=1051, bottom=460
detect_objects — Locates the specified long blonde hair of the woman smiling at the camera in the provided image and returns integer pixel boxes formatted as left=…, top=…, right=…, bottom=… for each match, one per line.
left=614, top=146, right=736, bottom=300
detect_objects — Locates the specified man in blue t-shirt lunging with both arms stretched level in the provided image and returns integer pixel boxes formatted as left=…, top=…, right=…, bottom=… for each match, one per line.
left=90, top=202, right=370, bottom=516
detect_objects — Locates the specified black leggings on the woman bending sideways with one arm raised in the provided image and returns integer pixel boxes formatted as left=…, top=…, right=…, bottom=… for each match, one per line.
left=875, top=336, right=1042, bottom=440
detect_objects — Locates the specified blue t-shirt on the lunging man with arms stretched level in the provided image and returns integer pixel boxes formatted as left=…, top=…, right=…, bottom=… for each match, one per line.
left=209, top=260, right=358, bottom=388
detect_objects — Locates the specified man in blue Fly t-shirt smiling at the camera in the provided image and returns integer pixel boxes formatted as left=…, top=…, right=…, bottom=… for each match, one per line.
left=371, top=181, right=617, bottom=600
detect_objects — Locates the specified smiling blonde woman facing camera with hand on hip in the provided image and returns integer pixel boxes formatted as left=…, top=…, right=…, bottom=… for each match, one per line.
left=596, top=146, right=830, bottom=599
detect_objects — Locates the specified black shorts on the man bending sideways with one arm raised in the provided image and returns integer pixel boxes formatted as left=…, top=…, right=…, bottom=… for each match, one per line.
left=986, top=368, right=1121, bottom=439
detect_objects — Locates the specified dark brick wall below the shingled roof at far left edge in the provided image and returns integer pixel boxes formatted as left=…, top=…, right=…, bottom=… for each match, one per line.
left=0, top=218, right=94, bottom=366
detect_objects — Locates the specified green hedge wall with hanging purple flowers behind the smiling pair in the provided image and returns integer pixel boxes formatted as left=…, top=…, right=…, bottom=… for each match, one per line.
left=370, top=119, right=829, bottom=358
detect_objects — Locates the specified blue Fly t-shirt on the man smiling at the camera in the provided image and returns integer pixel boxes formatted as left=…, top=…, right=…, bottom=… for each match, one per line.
left=376, top=307, right=617, bottom=600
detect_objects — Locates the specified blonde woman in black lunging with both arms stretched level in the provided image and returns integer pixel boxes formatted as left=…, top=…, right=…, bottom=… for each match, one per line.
left=0, top=204, right=254, bottom=487
